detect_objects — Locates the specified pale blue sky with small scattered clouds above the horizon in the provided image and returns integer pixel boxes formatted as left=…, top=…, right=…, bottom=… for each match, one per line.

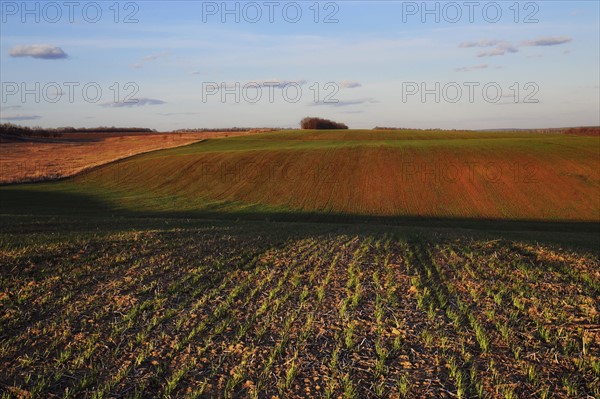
left=0, top=0, right=600, bottom=130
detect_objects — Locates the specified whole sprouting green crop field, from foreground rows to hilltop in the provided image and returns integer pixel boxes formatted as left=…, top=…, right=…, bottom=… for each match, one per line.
left=0, top=131, right=600, bottom=399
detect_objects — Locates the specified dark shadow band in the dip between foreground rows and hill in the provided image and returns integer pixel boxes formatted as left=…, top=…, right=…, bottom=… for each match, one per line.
left=0, top=186, right=600, bottom=248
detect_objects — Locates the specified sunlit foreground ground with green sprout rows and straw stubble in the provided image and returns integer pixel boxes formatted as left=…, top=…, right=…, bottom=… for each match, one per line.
left=0, top=223, right=600, bottom=399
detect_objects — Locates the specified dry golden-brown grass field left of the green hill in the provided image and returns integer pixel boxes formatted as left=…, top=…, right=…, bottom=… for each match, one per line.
left=0, top=132, right=255, bottom=183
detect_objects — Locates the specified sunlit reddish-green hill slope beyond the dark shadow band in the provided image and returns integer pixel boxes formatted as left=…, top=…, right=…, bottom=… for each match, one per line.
left=1, top=131, right=600, bottom=222
